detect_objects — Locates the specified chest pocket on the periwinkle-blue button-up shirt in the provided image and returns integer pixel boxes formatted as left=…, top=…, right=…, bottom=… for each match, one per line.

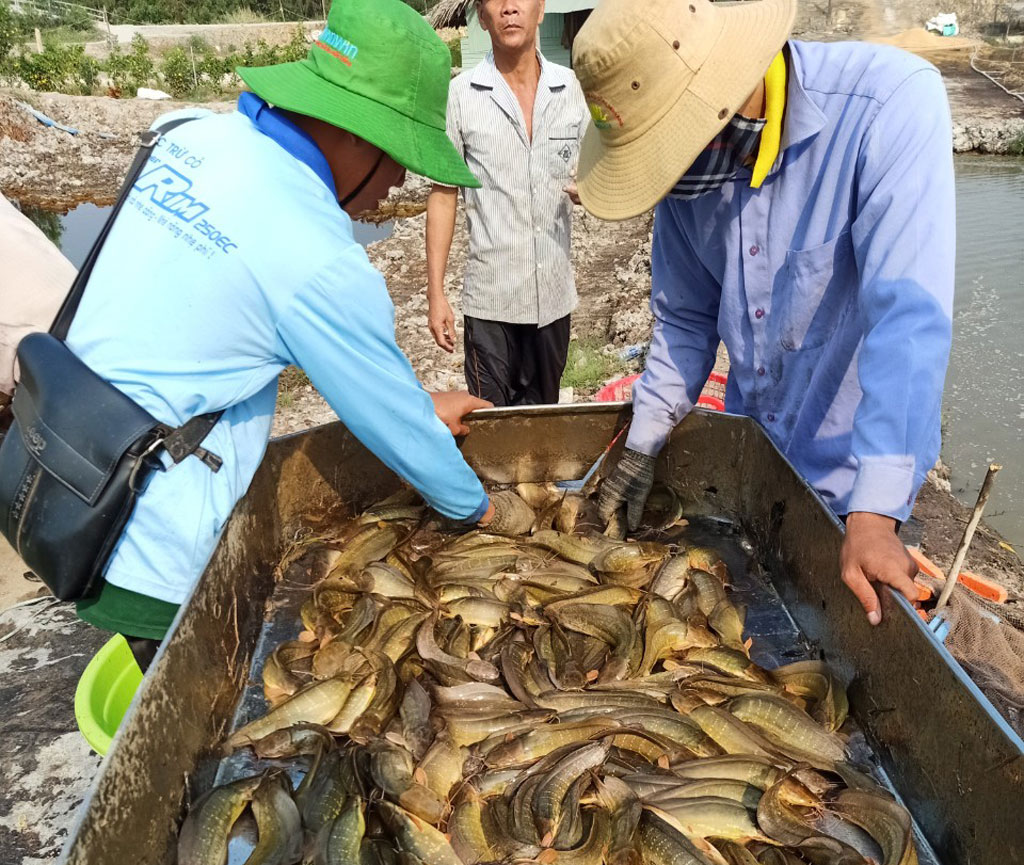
left=778, top=231, right=856, bottom=351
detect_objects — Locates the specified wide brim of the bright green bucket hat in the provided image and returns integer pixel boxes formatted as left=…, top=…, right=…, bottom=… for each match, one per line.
left=237, top=60, right=480, bottom=188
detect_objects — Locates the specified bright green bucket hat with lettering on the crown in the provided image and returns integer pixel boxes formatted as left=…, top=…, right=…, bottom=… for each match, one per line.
left=238, top=0, right=480, bottom=186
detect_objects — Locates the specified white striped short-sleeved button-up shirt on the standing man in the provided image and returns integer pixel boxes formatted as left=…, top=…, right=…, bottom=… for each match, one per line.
left=447, top=53, right=589, bottom=327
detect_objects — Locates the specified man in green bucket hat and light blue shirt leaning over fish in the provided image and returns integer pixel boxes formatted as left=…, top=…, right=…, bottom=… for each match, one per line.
left=69, top=0, right=516, bottom=665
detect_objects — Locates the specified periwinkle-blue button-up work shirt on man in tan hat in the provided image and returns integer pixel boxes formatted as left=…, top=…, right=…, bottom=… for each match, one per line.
left=628, top=42, right=955, bottom=520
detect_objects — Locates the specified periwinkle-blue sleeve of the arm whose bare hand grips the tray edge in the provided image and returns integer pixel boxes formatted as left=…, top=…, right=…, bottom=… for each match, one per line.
left=848, top=70, right=955, bottom=520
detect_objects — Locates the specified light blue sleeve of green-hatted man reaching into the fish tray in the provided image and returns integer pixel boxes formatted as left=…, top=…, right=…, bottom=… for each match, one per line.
left=278, top=244, right=487, bottom=521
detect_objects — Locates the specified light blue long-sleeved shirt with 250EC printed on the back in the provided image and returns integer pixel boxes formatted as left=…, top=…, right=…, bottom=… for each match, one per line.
left=68, top=94, right=487, bottom=603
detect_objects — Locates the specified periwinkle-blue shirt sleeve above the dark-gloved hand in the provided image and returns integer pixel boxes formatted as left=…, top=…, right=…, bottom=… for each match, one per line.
left=627, top=201, right=722, bottom=455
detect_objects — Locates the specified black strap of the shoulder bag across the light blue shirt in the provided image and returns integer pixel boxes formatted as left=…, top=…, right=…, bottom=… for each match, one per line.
left=50, top=117, right=224, bottom=472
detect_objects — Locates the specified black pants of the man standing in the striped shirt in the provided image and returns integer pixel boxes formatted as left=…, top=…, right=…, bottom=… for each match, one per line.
left=464, top=315, right=569, bottom=405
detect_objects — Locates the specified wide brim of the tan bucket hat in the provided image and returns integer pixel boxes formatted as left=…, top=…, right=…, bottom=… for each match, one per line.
left=578, top=0, right=797, bottom=220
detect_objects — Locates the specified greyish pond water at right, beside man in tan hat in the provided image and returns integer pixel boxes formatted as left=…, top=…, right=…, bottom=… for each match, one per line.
left=942, top=156, right=1024, bottom=547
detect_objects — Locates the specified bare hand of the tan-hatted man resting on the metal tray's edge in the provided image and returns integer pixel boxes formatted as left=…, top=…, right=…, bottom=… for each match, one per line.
left=840, top=512, right=918, bottom=624
